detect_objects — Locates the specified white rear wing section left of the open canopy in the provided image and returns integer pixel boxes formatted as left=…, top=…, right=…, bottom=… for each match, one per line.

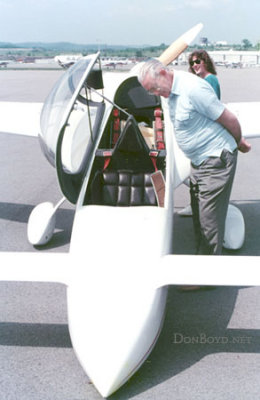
left=0, top=101, right=43, bottom=136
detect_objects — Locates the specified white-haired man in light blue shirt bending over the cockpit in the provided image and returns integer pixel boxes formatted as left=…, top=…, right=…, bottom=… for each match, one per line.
left=138, top=59, right=251, bottom=255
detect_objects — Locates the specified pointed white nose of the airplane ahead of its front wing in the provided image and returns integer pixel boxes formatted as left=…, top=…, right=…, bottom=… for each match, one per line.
left=67, top=264, right=166, bottom=397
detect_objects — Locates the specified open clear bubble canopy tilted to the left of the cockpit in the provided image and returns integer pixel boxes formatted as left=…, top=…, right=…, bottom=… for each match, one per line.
left=40, top=53, right=104, bottom=203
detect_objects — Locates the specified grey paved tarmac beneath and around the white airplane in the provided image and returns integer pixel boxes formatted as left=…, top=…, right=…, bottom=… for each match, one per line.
left=0, top=67, right=260, bottom=400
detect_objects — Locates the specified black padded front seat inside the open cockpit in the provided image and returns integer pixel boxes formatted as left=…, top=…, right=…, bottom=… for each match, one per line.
left=86, top=116, right=160, bottom=206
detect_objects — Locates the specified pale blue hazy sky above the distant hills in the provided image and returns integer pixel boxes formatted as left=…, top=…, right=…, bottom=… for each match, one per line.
left=0, top=0, right=260, bottom=46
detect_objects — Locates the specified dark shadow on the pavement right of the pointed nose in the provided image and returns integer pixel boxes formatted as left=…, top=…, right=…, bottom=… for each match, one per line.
left=110, top=286, right=260, bottom=400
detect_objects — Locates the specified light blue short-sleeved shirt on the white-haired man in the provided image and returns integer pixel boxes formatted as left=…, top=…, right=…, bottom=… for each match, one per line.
left=169, top=70, right=237, bottom=165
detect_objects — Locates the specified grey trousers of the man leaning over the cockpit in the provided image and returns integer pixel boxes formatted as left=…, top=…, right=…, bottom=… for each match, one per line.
left=190, top=150, right=237, bottom=255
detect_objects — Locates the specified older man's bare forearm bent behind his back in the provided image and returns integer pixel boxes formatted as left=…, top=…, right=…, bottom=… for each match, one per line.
left=216, top=108, right=251, bottom=153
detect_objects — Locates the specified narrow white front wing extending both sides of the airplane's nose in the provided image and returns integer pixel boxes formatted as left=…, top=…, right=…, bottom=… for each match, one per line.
left=0, top=252, right=260, bottom=290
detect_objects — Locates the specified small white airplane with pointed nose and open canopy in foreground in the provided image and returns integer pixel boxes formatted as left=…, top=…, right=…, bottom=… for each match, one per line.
left=0, top=24, right=260, bottom=397
